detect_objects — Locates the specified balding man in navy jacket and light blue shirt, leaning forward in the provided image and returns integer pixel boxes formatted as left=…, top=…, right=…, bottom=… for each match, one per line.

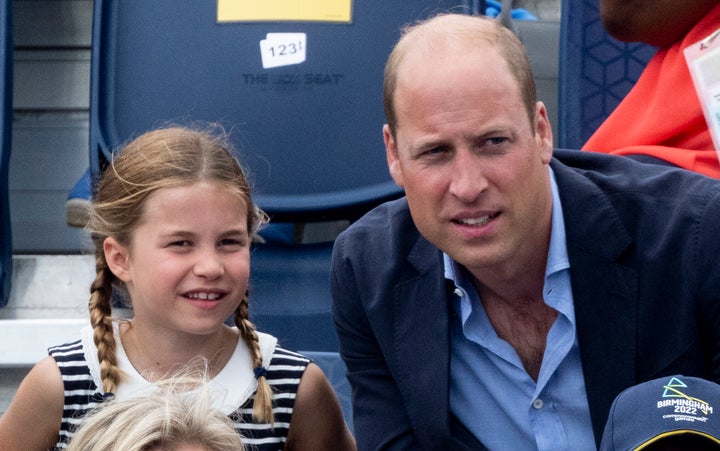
left=331, top=14, right=720, bottom=450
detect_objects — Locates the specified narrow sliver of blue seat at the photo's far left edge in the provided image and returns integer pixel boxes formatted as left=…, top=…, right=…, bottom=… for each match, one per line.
left=0, top=0, right=13, bottom=307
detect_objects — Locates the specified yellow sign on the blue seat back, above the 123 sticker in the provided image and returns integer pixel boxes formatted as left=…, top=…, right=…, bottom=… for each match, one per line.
left=217, top=0, right=352, bottom=23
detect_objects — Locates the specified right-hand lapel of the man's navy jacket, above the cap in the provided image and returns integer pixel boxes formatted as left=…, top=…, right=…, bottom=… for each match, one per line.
left=553, top=157, right=638, bottom=441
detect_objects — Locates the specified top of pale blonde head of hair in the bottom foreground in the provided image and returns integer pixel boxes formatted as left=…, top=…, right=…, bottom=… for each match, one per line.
left=67, top=370, right=245, bottom=451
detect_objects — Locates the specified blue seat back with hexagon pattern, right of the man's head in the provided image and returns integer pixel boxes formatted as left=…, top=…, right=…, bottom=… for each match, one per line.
left=558, top=0, right=656, bottom=149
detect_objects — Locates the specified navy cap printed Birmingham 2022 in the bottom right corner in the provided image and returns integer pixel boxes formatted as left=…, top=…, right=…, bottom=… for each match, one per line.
left=600, top=375, right=720, bottom=451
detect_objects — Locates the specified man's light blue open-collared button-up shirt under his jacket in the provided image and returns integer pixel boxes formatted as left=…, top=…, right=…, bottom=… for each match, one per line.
left=444, top=169, right=597, bottom=451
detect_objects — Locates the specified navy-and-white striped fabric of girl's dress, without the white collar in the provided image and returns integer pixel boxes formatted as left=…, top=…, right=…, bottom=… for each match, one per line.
left=49, top=340, right=310, bottom=451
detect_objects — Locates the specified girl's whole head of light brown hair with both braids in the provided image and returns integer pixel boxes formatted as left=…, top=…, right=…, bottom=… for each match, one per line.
left=87, top=126, right=273, bottom=423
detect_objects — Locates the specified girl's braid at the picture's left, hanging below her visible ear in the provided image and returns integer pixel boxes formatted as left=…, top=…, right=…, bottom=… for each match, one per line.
left=89, top=252, right=120, bottom=393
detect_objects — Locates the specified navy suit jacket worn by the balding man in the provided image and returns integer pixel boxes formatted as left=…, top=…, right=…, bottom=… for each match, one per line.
left=331, top=150, right=720, bottom=450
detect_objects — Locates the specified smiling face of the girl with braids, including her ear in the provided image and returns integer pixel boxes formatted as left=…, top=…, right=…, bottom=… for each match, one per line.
left=104, top=182, right=250, bottom=335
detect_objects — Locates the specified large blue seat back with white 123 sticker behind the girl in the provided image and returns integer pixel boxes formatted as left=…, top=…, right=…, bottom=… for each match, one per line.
left=90, top=0, right=470, bottom=220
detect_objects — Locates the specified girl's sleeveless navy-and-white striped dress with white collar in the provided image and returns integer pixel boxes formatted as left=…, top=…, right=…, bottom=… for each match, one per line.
left=48, top=327, right=310, bottom=451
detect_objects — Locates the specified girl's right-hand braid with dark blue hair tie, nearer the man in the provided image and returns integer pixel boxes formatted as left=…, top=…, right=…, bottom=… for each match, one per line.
left=235, top=291, right=275, bottom=425
